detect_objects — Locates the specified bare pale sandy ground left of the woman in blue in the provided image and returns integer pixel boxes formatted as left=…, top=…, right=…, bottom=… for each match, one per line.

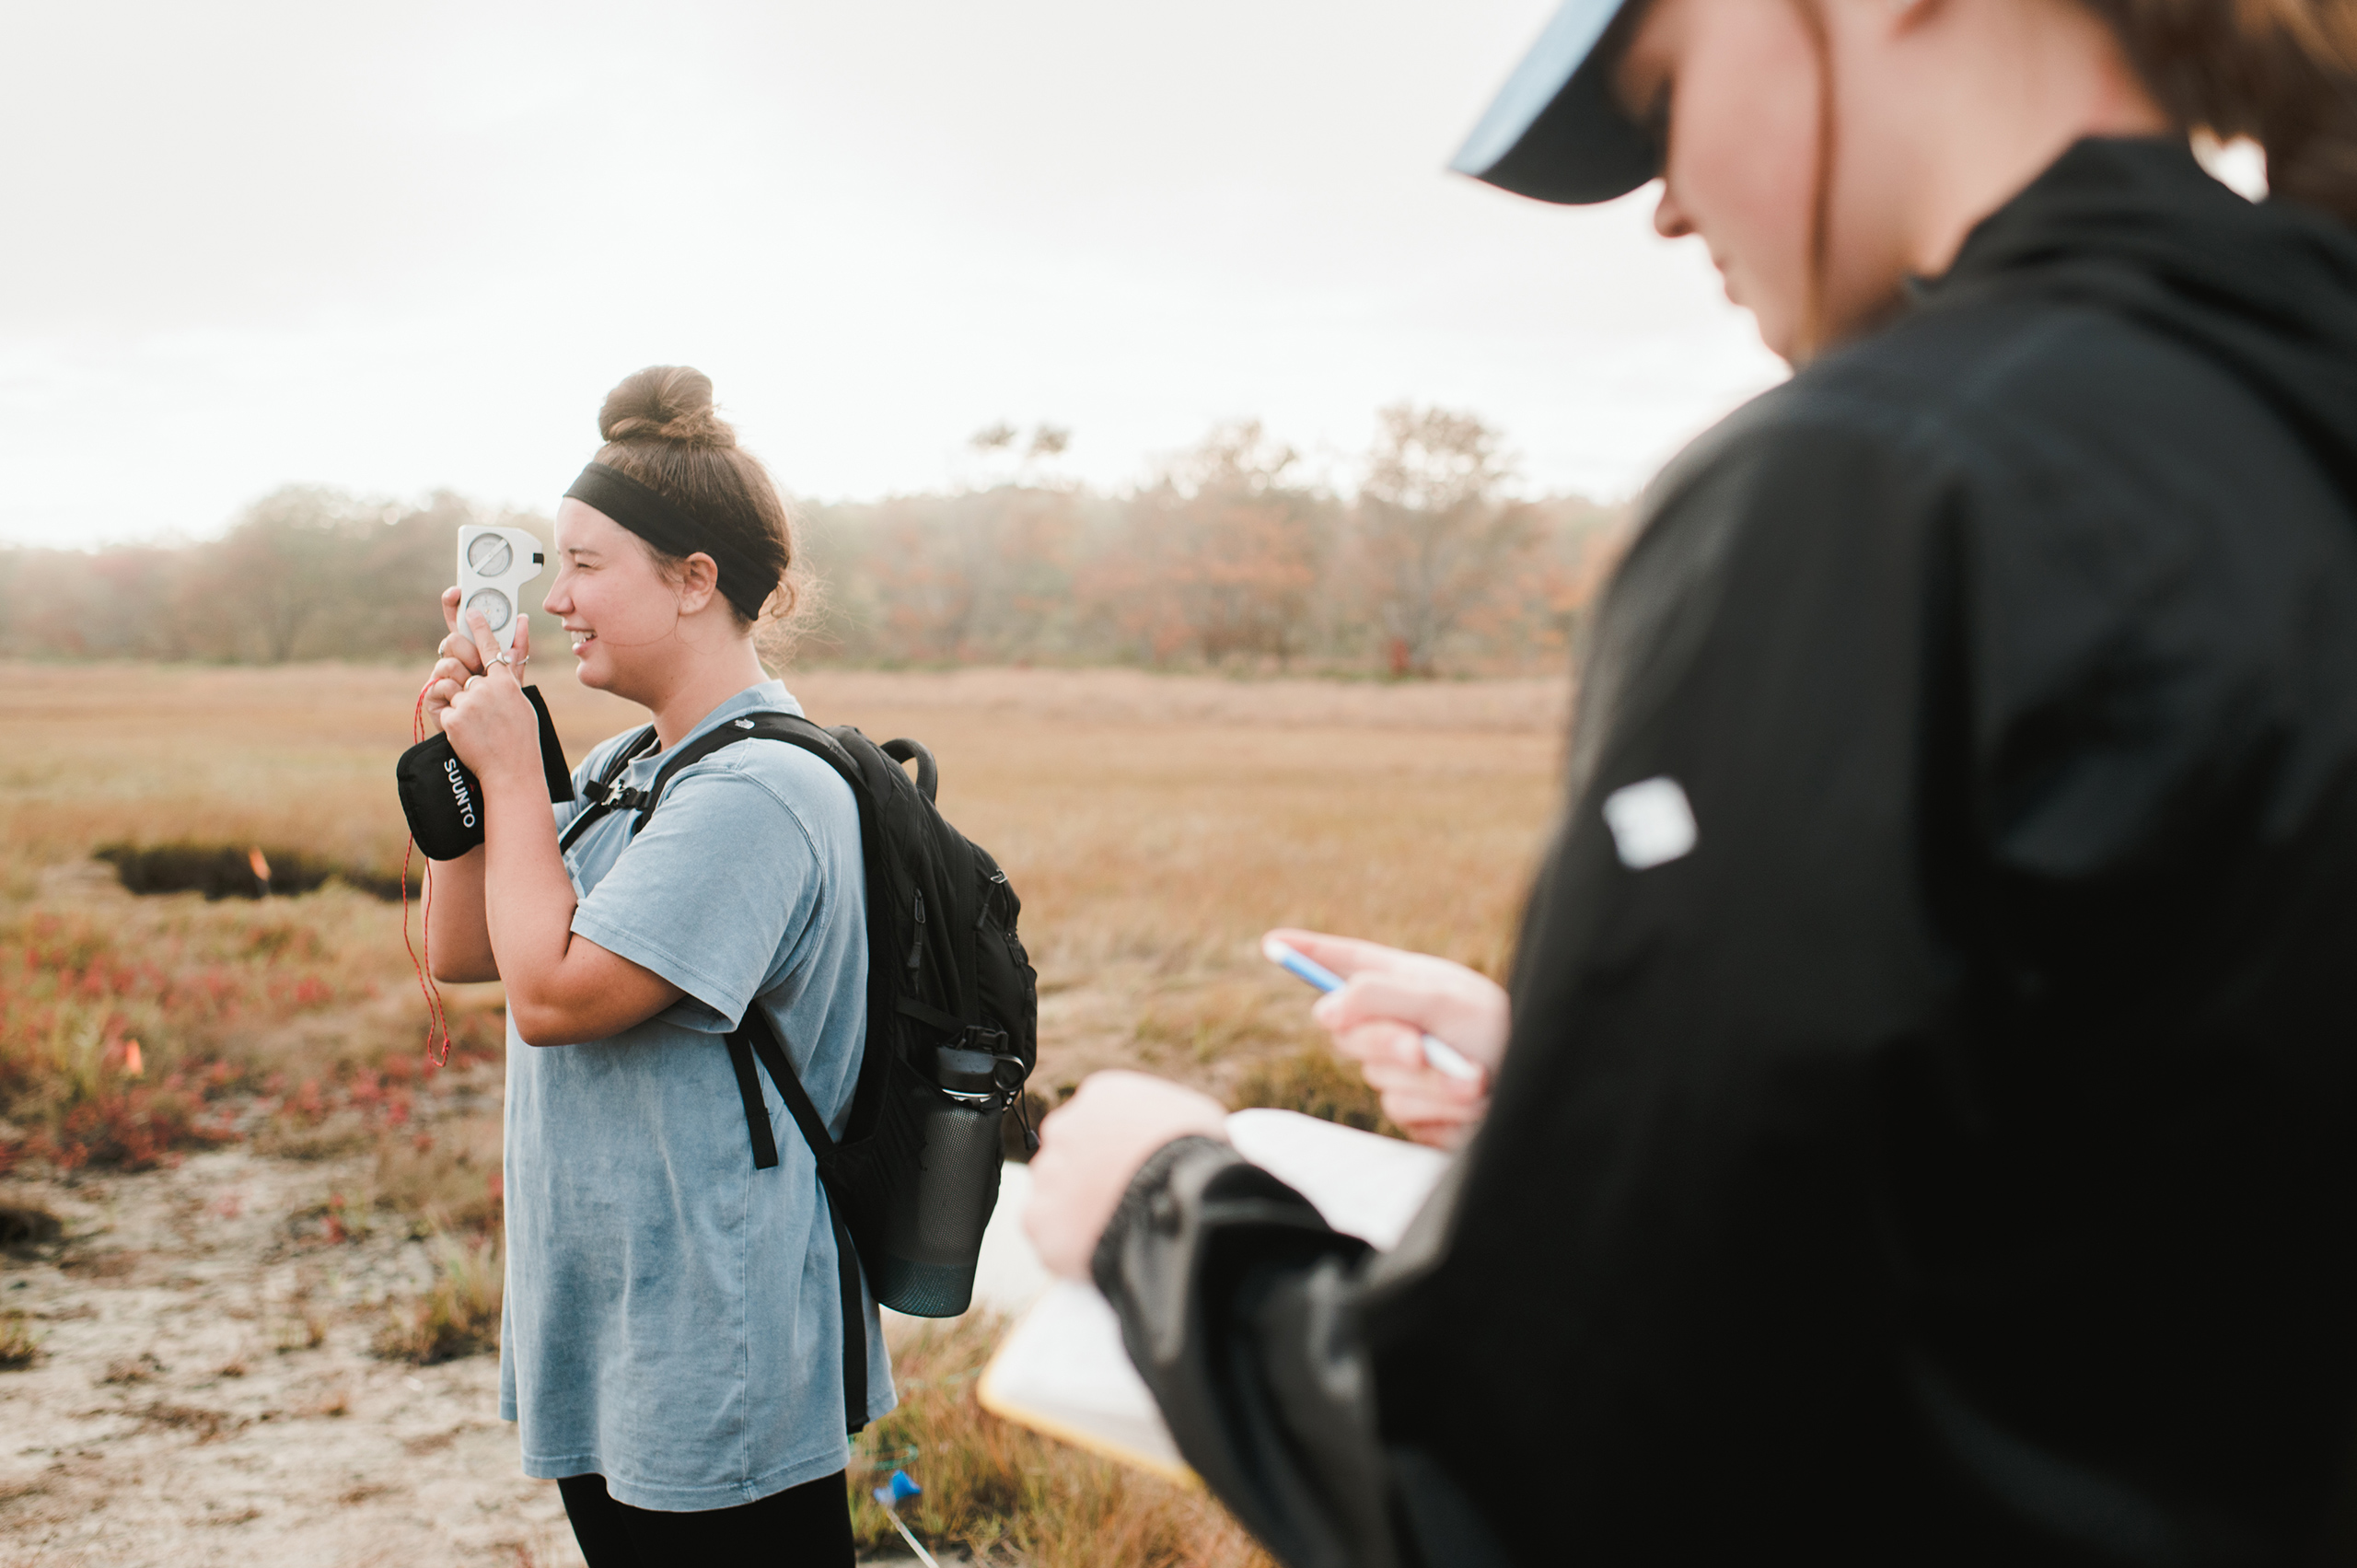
left=0, top=1148, right=580, bottom=1568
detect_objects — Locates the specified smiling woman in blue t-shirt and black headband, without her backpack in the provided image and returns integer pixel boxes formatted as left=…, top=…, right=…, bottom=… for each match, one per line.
left=426, top=368, right=893, bottom=1568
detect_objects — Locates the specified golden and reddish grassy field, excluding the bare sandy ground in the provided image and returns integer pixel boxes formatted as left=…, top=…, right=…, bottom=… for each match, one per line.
left=0, top=665, right=1567, bottom=1565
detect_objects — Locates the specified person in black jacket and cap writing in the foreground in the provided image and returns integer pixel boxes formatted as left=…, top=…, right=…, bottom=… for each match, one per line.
left=1028, top=0, right=2357, bottom=1568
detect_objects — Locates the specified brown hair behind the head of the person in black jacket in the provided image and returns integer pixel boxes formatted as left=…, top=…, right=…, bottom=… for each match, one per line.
left=2084, top=0, right=2357, bottom=224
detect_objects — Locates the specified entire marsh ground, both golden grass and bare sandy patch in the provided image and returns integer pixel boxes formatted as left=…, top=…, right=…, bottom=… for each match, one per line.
left=0, top=665, right=1567, bottom=1568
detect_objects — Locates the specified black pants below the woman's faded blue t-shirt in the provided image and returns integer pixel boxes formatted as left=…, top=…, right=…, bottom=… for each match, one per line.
left=556, top=1471, right=851, bottom=1568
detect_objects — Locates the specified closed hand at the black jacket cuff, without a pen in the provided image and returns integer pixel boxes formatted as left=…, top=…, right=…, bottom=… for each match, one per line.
left=1023, top=1073, right=1228, bottom=1281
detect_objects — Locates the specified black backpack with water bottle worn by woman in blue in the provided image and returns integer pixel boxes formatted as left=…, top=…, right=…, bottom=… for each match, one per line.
left=561, top=712, right=1039, bottom=1431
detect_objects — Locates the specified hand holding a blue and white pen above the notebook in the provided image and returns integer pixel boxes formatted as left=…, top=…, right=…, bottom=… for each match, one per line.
left=1268, top=932, right=1511, bottom=1148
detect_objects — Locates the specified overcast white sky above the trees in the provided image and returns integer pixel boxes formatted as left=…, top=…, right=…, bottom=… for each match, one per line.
left=0, top=0, right=1782, bottom=542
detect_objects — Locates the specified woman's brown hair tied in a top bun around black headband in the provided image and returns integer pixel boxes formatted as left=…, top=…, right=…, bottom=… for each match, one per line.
left=597, top=366, right=799, bottom=625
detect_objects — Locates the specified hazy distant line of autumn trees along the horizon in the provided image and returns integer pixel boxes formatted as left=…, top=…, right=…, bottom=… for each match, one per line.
left=0, top=405, right=1624, bottom=677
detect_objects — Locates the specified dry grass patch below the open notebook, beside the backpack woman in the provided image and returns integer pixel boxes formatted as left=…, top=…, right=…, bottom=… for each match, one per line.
left=849, top=1313, right=1272, bottom=1568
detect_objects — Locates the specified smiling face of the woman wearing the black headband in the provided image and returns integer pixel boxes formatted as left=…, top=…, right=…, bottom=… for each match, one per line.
left=542, top=495, right=681, bottom=701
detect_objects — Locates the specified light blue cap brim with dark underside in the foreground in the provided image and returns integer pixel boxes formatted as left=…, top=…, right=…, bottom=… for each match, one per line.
left=1449, top=0, right=1662, bottom=203
